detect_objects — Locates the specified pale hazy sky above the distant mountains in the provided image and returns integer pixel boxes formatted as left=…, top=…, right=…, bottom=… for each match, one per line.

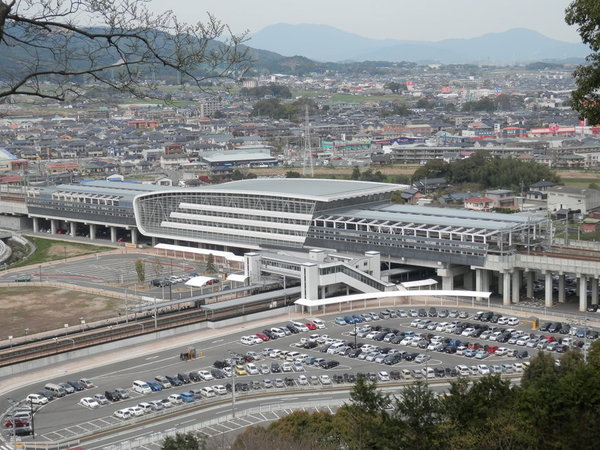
left=151, top=0, right=580, bottom=46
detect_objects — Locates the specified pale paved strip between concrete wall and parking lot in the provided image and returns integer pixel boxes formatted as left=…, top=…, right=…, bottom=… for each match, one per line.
left=0, top=313, right=303, bottom=395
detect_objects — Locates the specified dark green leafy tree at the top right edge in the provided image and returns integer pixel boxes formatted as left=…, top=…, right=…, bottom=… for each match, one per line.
left=565, top=0, right=600, bottom=125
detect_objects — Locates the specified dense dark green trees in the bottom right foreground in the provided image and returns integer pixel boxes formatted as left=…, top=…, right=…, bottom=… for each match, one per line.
left=225, top=343, right=600, bottom=450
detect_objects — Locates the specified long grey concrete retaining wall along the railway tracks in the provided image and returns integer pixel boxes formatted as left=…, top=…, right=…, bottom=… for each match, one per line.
left=0, top=308, right=285, bottom=377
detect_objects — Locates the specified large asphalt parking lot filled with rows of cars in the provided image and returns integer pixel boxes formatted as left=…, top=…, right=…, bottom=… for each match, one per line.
left=5, top=308, right=598, bottom=441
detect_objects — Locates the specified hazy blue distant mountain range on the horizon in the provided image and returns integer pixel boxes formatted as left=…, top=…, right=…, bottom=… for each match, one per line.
left=248, top=24, right=589, bottom=64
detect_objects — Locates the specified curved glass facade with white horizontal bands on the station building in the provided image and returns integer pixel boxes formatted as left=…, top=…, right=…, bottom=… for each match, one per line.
left=134, top=191, right=315, bottom=247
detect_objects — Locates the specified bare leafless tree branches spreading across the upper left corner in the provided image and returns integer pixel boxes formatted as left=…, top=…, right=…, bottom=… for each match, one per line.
left=0, top=0, right=248, bottom=100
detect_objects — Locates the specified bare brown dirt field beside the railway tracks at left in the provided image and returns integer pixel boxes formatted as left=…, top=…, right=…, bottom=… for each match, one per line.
left=0, top=288, right=124, bottom=339
